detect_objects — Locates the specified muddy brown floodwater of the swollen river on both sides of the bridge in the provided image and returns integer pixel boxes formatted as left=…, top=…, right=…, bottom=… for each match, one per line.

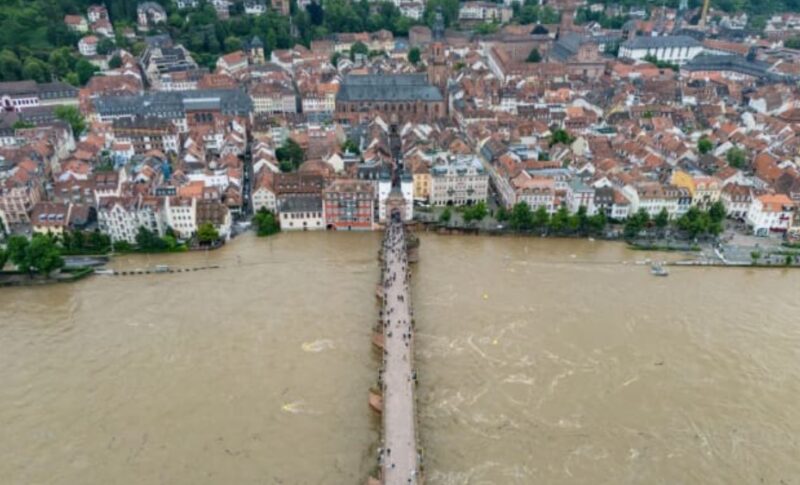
left=0, top=233, right=800, bottom=485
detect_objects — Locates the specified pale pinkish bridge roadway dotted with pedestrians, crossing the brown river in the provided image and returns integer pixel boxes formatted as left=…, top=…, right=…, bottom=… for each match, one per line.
left=380, top=221, right=421, bottom=485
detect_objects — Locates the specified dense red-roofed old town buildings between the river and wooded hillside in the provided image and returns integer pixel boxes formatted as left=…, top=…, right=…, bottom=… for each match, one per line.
left=0, top=1, right=800, bottom=242
